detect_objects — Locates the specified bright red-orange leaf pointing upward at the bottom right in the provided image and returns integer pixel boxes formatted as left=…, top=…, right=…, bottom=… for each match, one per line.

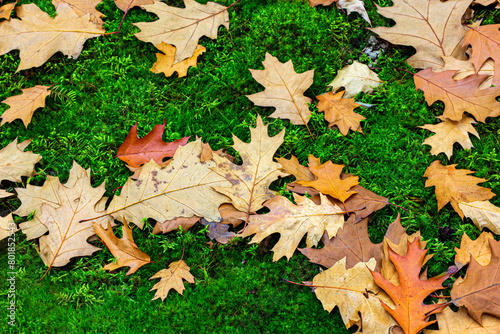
left=371, top=238, right=454, bottom=334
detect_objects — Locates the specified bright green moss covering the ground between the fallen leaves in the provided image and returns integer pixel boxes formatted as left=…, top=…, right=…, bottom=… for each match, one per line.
left=0, top=0, right=500, bottom=334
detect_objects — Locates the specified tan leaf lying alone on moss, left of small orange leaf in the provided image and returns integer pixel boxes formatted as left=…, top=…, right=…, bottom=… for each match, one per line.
left=246, top=52, right=314, bottom=126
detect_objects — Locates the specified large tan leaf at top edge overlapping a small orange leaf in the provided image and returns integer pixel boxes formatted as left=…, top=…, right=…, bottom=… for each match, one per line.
left=134, top=0, right=229, bottom=64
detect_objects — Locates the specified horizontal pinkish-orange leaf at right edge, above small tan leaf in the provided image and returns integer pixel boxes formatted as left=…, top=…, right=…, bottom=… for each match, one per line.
left=413, top=68, right=500, bottom=122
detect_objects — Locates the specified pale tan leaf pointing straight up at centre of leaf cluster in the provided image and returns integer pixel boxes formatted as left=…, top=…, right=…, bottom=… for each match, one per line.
left=212, top=116, right=288, bottom=215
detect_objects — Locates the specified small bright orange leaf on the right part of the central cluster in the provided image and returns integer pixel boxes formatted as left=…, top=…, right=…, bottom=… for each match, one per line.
left=297, top=161, right=359, bottom=203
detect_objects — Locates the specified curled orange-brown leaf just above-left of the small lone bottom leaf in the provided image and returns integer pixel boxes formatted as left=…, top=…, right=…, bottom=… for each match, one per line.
left=92, top=221, right=151, bottom=275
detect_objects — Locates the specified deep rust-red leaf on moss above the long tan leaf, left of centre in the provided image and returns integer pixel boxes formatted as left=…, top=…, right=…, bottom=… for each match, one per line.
left=116, top=120, right=189, bottom=168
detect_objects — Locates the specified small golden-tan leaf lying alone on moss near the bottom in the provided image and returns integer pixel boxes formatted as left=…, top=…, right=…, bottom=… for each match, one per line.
left=149, top=260, right=194, bottom=301
